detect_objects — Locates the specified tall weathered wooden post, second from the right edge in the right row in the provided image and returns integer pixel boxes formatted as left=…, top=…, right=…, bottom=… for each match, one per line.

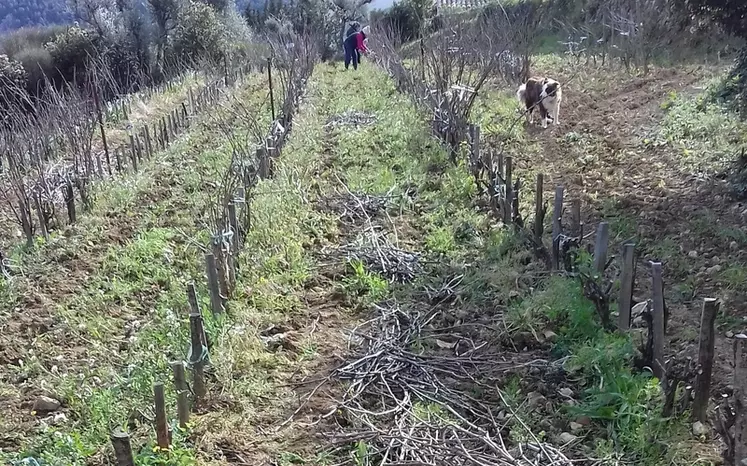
left=692, top=298, right=719, bottom=424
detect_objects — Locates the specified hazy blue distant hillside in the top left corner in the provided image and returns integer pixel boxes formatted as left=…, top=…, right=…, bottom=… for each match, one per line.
left=0, top=0, right=71, bottom=32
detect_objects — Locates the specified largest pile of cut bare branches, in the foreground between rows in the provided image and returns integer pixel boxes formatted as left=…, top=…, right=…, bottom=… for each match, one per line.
left=312, top=303, right=571, bottom=466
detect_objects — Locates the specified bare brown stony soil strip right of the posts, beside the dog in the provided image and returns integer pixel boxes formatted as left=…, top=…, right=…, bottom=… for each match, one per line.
left=506, top=61, right=747, bottom=396
